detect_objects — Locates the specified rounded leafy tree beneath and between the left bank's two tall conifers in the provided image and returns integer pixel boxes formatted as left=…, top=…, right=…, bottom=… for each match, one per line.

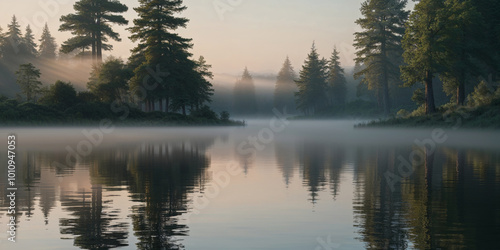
left=87, top=57, right=133, bottom=103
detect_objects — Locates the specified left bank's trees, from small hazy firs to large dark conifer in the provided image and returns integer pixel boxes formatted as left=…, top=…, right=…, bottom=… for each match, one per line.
left=0, top=0, right=214, bottom=118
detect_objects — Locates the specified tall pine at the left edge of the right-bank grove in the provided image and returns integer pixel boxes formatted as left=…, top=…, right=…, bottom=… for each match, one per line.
left=354, top=0, right=409, bottom=115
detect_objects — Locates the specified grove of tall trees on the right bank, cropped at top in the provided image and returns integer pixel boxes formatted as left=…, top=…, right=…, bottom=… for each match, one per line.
left=354, top=0, right=500, bottom=114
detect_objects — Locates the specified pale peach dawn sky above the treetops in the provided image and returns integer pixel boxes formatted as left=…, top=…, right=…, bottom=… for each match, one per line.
left=0, top=0, right=413, bottom=76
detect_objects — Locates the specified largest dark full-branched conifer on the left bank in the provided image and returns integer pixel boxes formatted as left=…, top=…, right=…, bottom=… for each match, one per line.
left=129, top=0, right=196, bottom=112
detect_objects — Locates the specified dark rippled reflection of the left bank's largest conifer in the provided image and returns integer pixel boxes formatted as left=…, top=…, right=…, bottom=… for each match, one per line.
left=129, top=142, right=210, bottom=249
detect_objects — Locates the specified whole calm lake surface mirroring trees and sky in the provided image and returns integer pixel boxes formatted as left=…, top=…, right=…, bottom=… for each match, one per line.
left=0, top=119, right=500, bottom=250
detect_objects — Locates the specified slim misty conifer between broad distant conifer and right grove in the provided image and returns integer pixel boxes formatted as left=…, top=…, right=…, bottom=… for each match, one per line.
left=327, top=48, right=347, bottom=109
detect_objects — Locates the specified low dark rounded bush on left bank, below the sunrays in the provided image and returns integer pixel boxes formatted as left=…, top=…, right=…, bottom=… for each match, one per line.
left=39, top=81, right=78, bottom=110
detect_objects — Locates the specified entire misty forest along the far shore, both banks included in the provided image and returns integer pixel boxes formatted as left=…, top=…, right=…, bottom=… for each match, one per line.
left=0, top=0, right=500, bottom=126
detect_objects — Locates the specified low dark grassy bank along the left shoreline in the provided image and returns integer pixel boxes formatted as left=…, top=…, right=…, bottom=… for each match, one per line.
left=0, top=99, right=244, bottom=126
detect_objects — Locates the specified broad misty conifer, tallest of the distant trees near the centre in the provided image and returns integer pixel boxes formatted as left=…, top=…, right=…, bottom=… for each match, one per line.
left=295, top=43, right=328, bottom=115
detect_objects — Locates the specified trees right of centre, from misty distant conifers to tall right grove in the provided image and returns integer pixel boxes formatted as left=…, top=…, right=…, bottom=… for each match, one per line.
left=240, top=0, right=500, bottom=115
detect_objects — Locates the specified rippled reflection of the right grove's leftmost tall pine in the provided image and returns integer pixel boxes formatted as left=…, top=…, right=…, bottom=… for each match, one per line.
left=353, top=148, right=408, bottom=249
